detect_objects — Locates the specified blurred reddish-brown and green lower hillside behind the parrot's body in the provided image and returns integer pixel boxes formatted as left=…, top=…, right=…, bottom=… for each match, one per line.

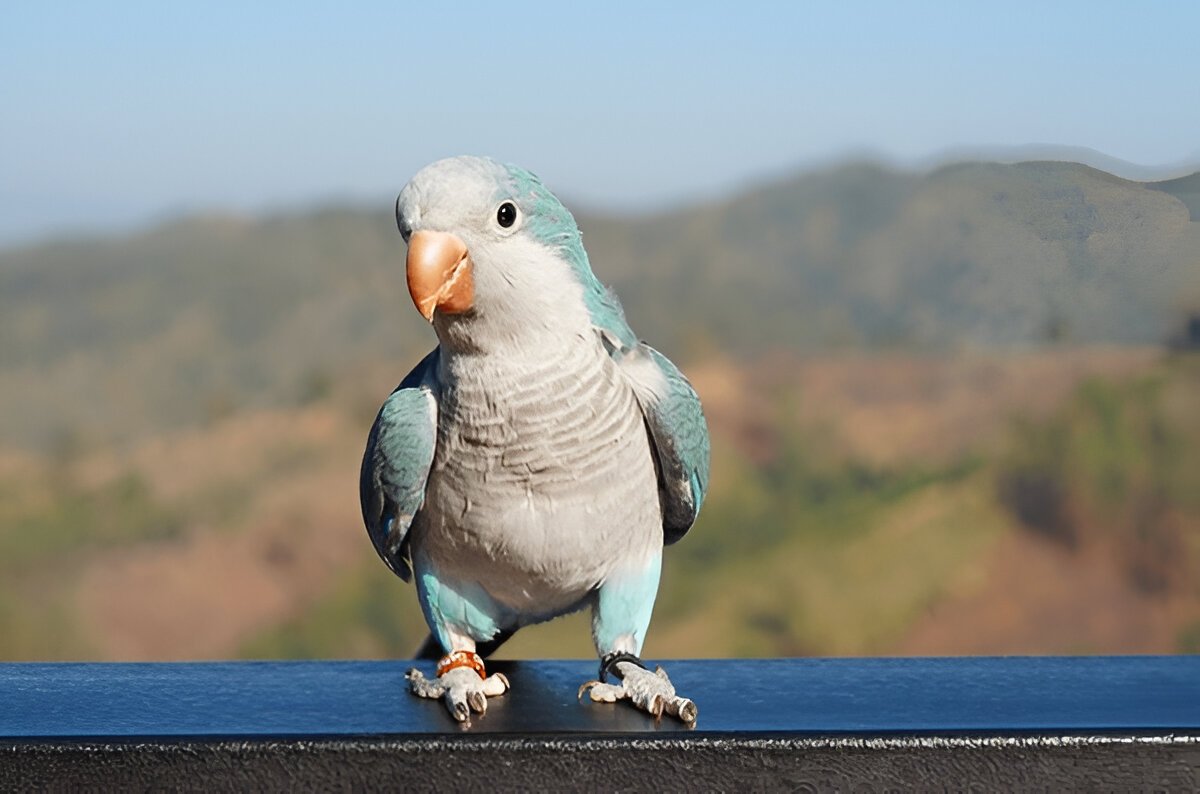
left=0, top=348, right=1200, bottom=660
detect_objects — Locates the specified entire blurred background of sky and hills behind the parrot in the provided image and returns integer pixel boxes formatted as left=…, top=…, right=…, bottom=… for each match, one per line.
left=0, top=1, right=1200, bottom=660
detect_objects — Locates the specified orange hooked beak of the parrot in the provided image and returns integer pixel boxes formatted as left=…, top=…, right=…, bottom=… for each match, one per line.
left=407, top=231, right=475, bottom=321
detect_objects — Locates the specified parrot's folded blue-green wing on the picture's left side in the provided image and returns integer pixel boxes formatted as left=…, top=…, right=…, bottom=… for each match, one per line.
left=359, top=349, right=438, bottom=582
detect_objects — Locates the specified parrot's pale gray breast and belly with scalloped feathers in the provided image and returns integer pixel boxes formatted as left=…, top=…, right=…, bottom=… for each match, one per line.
left=414, top=345, right=662, bottom=608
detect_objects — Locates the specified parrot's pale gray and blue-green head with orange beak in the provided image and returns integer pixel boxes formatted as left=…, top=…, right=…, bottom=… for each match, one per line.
left=396, top=157, right=602, bottom=342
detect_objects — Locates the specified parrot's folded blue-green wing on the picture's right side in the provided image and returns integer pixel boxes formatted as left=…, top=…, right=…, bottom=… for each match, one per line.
left=614, top=343, right=709, bottom=545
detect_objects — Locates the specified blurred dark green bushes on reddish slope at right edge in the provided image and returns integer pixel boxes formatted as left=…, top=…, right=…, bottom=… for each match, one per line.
left=997, top=354, right=1200, bottom=591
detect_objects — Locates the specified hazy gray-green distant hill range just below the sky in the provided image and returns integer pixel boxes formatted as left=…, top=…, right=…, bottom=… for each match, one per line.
left=0, top=163, right=1200, bottom=449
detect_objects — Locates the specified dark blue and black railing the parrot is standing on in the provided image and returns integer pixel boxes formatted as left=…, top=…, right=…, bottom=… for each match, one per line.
left=0, top=656, right=1200, bottom=792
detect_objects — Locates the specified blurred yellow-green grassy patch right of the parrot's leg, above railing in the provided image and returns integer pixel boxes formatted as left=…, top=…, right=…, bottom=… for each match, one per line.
left=650, top=477, right=1007, bottom=656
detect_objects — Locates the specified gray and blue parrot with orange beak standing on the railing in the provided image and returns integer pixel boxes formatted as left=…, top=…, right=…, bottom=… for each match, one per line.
left=360, top=157, right=709, bottom=723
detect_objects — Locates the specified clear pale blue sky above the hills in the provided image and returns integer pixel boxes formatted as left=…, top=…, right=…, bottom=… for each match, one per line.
left=0, top=0, right=1200, bottom=245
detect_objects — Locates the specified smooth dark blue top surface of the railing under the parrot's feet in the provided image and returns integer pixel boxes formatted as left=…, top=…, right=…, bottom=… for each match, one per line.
left=0, top=656, right=1200, bottom=739
